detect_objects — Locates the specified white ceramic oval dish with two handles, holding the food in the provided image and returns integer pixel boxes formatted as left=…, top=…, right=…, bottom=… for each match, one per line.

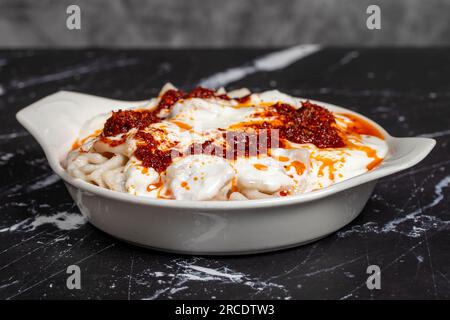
left=16, top=91, right=435, bottom=255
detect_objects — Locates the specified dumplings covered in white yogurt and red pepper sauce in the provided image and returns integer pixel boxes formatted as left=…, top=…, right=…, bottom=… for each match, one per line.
left=64, top=84, right=388, bottom=201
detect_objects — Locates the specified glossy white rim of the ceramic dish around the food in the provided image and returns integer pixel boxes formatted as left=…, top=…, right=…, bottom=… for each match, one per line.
left=16, top=91, right=436, bottom=210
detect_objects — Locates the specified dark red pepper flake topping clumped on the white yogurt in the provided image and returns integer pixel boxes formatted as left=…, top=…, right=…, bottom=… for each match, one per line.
left=98, top=87, right=345, bottom=172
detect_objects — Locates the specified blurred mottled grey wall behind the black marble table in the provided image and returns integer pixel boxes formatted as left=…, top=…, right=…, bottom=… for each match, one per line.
left=0, top=0, right=450, bottom=48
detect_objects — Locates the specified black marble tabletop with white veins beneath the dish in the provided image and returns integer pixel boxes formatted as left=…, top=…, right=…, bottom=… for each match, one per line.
left=0, top=48, right=450, bottom=299
